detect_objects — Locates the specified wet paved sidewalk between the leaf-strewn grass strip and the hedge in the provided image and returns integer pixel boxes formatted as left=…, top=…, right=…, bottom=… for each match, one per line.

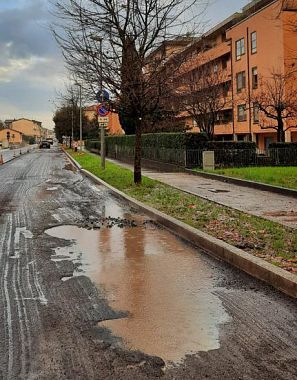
left=108, top=158, right=297, bottom=229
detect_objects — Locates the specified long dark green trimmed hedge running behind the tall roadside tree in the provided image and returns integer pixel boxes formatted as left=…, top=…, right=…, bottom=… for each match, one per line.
left=86, top=133, right=256, bottom=167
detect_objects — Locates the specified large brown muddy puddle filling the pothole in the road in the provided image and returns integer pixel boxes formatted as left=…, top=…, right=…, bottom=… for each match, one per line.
left=46, top=203, right=229, bottom=363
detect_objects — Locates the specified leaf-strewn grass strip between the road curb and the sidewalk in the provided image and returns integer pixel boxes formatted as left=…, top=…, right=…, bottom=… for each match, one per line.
left=68, top=151, right=297, bottom=271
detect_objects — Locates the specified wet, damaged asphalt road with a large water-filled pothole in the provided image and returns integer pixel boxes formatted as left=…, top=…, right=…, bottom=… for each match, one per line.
left=0, top=148, right=297, bottom=380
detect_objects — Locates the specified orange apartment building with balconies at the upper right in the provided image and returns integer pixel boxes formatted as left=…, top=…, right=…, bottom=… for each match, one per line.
left=171, top=0, right=297, bottom=150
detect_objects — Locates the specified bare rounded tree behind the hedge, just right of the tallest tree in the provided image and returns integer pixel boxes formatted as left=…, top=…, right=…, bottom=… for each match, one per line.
left=177, top=64, right=230, bottom=140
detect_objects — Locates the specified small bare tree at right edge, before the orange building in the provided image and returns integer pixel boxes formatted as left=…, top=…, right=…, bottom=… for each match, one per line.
left=252, top=72, right=297, bottom=142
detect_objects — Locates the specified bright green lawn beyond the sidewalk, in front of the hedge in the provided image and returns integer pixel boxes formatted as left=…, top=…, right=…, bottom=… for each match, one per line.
left=199, top=166, right=297, bottom=190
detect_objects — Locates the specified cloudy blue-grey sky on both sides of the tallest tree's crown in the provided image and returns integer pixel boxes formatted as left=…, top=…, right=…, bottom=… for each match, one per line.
left=0, top=0, right=249, bottom=128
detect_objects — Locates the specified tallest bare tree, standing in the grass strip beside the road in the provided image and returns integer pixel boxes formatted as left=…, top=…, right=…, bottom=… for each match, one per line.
left=53, top=0, right=206, bottom=183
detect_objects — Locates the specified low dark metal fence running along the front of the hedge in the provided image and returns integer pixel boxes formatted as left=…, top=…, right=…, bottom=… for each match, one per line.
left=107, top=145, right=297, bottom=168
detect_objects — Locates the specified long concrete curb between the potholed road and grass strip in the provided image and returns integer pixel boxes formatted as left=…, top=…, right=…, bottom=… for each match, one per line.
left=65, top=152, right=297, bottom=298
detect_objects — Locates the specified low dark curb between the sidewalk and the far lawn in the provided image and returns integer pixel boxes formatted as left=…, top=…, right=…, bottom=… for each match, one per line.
left=185, top=169, right=297, bottom=198
